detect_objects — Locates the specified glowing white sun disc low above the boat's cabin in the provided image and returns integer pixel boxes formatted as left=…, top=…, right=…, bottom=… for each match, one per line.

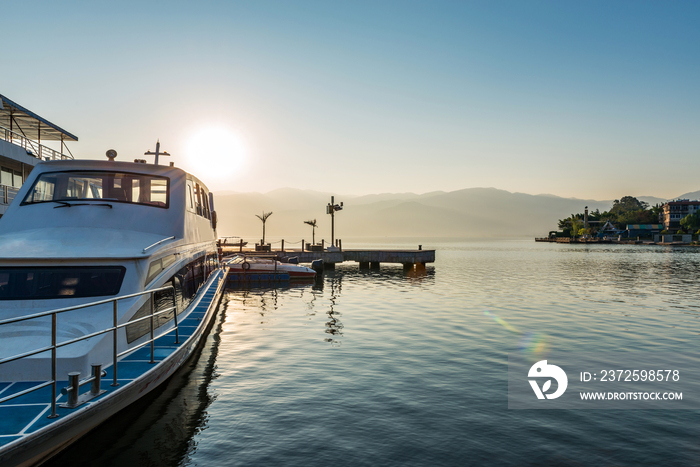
left=185, top=127, right=246, bottom=180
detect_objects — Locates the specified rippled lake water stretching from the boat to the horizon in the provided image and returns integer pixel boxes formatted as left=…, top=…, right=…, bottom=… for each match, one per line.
left=47, top=239, right=700, bottom=466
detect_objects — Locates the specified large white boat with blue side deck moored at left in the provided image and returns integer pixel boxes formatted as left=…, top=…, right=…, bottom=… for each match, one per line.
left=0, top=148, right=225, bottom=466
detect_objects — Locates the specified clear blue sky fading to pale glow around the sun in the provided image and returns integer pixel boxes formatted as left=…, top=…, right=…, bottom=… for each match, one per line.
left=0, top=0, right=700, bottom=199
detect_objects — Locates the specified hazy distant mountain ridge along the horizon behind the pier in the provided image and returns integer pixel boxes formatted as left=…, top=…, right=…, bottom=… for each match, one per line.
left=215, top=188, right=700, bottom=239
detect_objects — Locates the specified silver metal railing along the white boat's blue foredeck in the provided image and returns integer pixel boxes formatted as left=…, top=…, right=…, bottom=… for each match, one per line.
left=0, top=286, right=180, bottom=418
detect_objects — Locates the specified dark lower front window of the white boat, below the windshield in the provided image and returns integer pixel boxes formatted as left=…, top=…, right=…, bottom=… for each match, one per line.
left=0, top=266, right=126, bottom=300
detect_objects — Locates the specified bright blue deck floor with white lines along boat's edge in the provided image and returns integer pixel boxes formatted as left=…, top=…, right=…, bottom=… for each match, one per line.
left=0, top=271, right=223, bottom=448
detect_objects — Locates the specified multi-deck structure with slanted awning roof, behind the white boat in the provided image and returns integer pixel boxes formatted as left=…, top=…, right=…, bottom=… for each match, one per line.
left=0, top=94, right=78, bottom=217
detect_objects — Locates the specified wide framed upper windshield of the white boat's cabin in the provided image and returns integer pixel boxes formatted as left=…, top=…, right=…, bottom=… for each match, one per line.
left=22, top=171, right=169, bottom=208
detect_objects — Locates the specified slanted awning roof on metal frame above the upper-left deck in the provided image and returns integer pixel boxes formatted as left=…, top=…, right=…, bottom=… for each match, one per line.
left=0, top=94, right=78, bottom=141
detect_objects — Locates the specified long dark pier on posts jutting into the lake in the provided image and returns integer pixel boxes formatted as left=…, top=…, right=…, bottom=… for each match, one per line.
left=223, top=246, right=435, bottom=270
